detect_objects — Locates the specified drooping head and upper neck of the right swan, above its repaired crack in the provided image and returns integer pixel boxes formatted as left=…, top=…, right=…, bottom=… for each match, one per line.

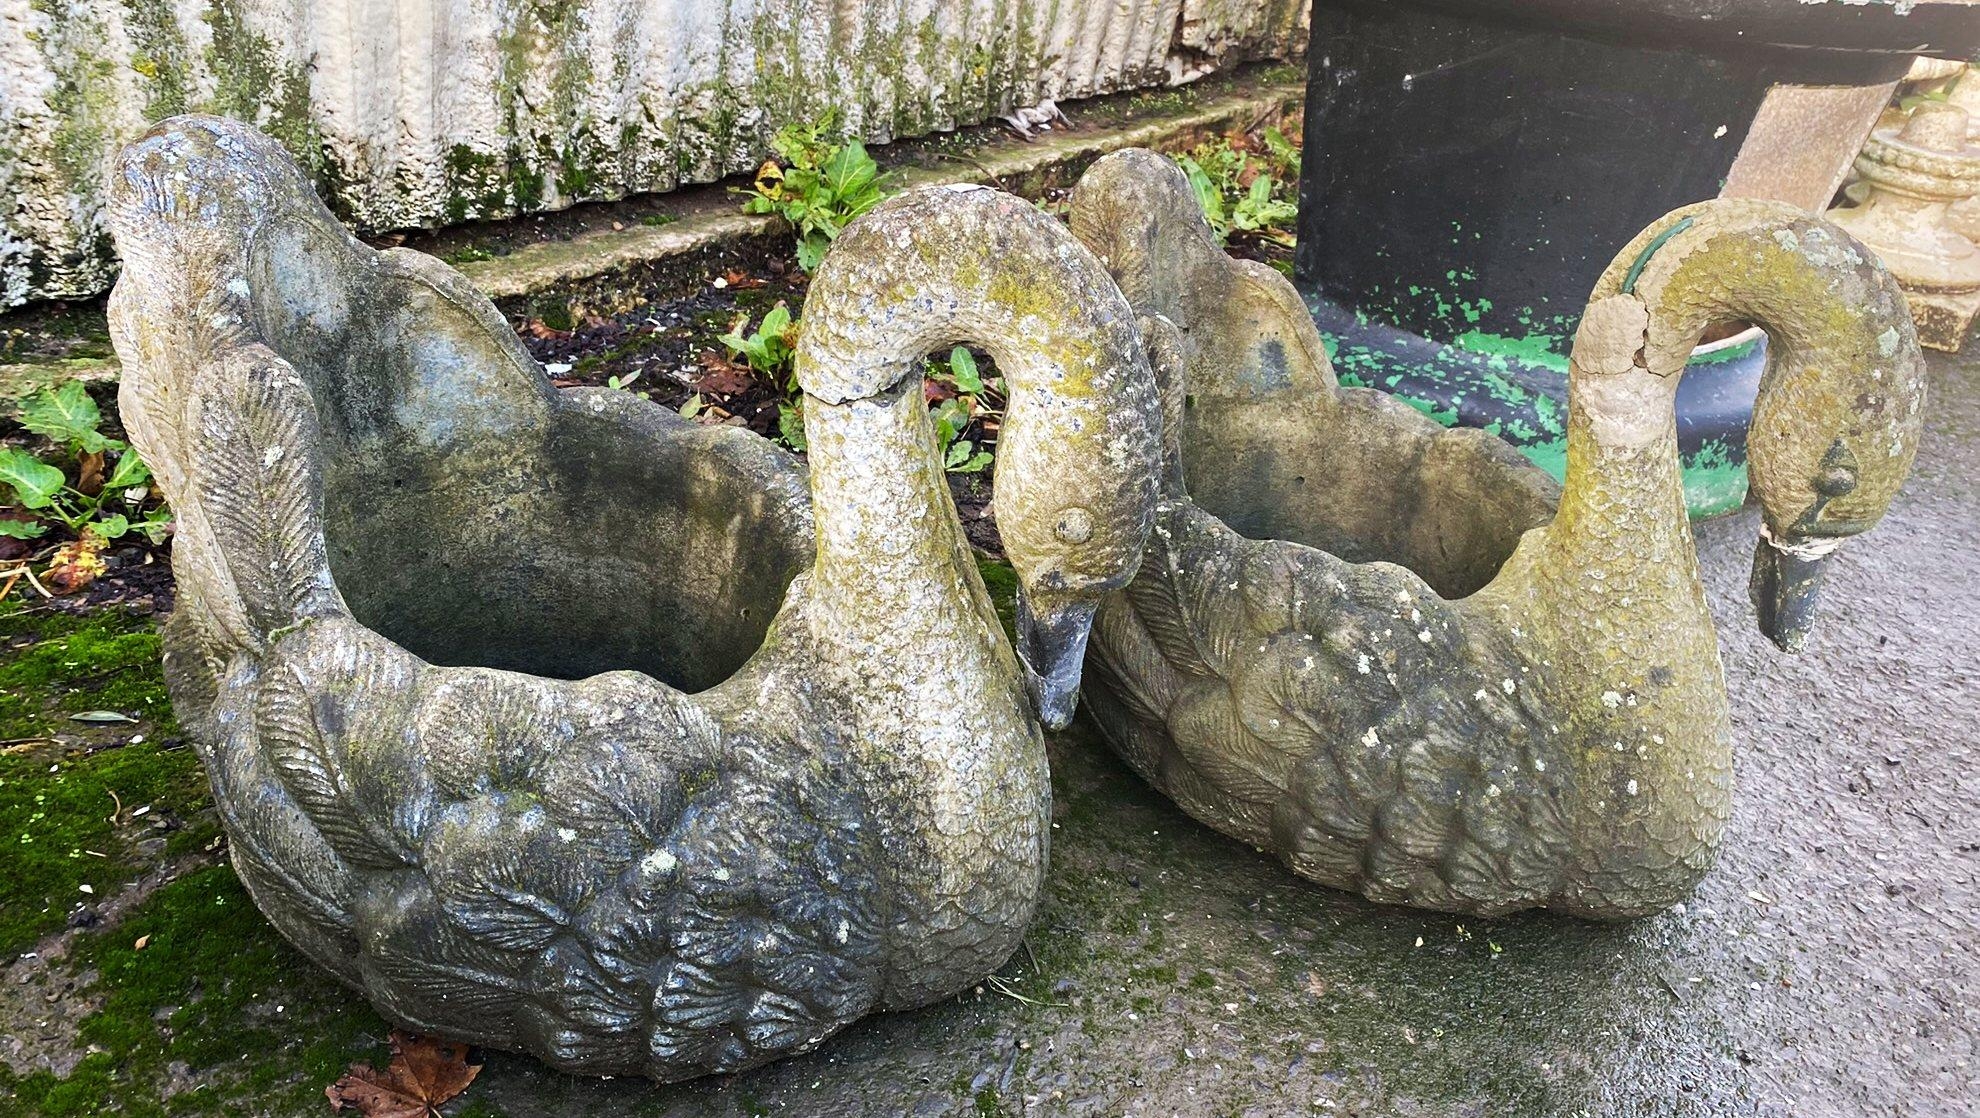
left=1596, top=198, right=1925, bottom=651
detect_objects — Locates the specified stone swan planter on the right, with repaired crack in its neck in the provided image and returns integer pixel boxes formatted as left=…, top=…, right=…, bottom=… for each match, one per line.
left=1073, top=152, right=1925, bottom=918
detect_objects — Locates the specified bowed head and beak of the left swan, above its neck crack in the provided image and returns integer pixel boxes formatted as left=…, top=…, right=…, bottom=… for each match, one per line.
left=798, top=184, right=1162, bottom=728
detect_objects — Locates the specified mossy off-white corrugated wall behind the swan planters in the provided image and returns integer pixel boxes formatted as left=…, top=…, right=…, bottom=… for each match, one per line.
left=0, top=0, right=1307, bottom=307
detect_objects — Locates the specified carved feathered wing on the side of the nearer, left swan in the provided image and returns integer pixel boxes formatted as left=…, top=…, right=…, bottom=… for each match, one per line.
left=214, top=619, right=883, bottom=1078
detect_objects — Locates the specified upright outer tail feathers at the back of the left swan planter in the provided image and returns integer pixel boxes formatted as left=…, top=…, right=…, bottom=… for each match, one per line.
left=109, top=117, right=360, bottom=722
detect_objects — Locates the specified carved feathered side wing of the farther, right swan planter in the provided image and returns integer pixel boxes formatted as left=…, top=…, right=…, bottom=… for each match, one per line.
left=1091, top=507, right=1568, bottom=910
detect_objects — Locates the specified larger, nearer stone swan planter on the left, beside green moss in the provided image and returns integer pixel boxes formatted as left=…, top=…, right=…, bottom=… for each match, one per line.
left=111, top=117, right=1158, bottom=1078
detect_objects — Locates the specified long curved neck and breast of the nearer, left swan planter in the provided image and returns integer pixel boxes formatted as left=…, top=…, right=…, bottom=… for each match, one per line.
left=798, top=188, right=1160, bottom=1007
